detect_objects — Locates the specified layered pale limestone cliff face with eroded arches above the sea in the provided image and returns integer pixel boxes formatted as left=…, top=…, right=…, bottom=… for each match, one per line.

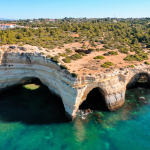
left=0, top=46, right=150, bottom=120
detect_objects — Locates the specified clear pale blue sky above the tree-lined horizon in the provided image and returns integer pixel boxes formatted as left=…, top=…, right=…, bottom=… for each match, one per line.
left=0, top=0, right=150, bottom=19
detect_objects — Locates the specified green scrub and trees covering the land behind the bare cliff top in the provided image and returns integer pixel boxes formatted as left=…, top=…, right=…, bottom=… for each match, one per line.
left=0, top=17, right=150, bottom=72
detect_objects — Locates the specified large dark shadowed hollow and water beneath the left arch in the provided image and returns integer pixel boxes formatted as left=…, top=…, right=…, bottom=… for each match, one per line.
left=0, top=79, right=67, bottom=124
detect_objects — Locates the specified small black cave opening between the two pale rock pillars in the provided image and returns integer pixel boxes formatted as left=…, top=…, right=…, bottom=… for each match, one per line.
left=79, top=87, right=108, bottom=111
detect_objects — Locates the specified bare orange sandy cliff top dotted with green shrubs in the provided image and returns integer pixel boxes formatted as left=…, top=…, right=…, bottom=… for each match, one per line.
left=0, top=42, right=150, bottom=76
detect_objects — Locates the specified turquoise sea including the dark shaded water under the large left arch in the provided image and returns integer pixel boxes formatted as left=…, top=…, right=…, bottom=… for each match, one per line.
left=0, top=84, right=150, bottom=150
